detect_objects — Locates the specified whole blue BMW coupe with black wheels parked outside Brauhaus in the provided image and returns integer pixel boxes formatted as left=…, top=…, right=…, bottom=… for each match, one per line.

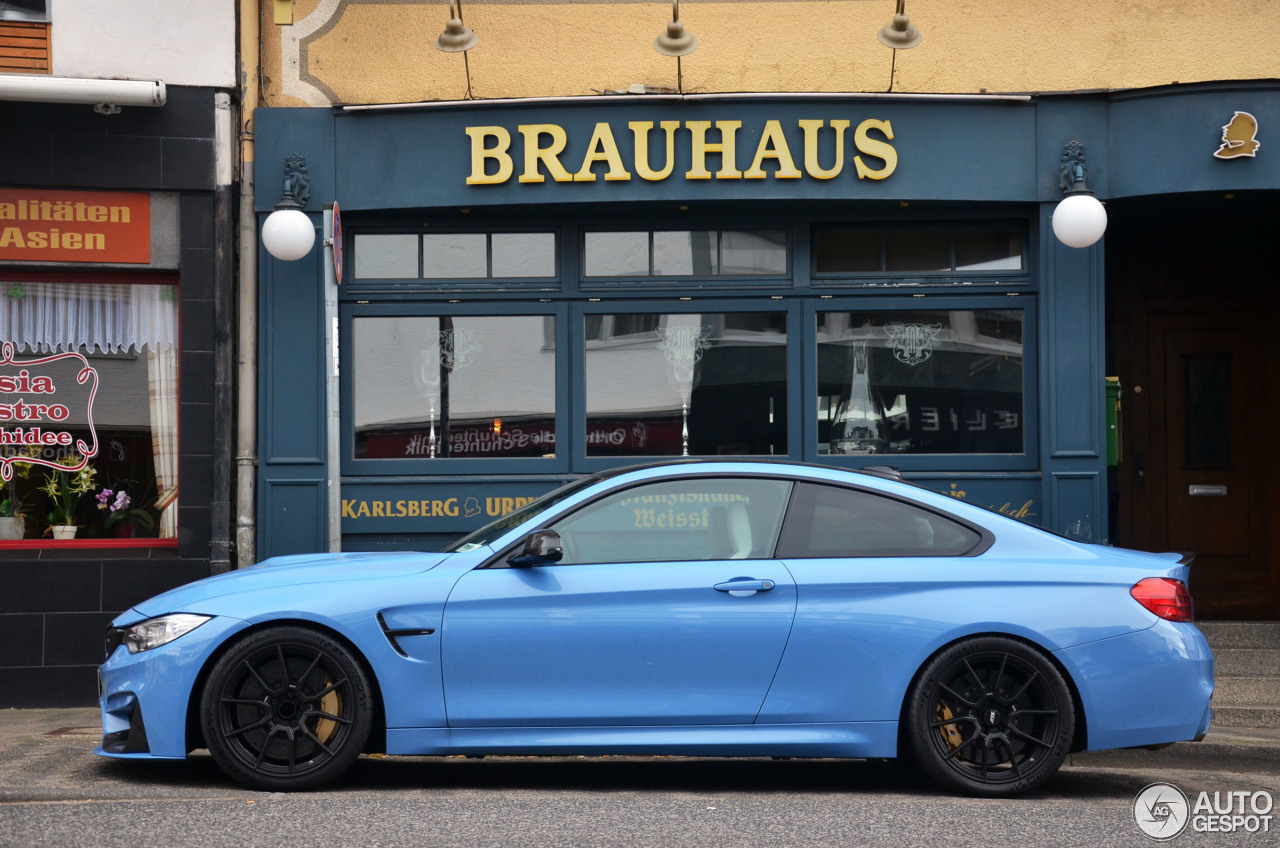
left=97, top=461, right=1213, bottom=797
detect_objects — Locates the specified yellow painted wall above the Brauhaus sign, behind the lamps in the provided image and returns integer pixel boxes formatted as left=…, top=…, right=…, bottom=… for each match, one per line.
left=261, top=0, right=1280, bottom=106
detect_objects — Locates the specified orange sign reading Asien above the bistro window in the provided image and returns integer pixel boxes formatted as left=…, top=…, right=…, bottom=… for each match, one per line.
left=0, top=188, right=151, bottom=264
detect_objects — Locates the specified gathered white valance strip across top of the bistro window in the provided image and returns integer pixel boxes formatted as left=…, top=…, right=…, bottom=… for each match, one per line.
left=0, top=283, right=178, bottom=354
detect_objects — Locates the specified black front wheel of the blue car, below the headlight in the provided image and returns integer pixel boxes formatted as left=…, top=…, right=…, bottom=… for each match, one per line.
left=201, top=626, right=372, bottom=792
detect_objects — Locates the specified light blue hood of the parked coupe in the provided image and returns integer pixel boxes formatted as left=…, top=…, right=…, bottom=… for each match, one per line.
left=129, top=552, right=449, bottom=619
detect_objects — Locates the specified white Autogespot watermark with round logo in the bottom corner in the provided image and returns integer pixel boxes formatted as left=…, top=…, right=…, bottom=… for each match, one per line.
left=1133, top=783, right=1275, bottom=839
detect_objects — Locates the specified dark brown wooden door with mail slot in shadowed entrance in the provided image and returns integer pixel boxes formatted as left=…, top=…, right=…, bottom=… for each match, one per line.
left=1119, top=301, right=1280, bottom=619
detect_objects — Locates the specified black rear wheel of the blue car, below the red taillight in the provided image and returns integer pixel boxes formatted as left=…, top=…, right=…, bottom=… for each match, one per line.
left=906, top=637, right=1075, bottom=797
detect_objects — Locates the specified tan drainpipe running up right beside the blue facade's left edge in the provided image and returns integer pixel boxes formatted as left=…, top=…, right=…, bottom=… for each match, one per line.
left=236, top=0, right=260, bottom=569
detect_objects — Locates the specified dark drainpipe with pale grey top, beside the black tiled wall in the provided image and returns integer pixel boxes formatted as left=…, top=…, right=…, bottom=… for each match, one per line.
left=209, top=91, right=236, bottom=574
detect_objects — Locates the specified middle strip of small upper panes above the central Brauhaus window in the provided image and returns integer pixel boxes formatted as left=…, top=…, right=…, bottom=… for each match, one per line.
left=582, top=229, right=787, bottom=278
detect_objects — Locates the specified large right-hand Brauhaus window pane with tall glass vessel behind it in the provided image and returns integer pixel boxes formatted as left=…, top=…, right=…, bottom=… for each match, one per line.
left=817, top=309, right=1025, bottom=453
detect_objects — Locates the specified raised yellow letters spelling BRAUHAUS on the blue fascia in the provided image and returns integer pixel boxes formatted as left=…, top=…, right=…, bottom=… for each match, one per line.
left=466, top=118, right=897, bottom=186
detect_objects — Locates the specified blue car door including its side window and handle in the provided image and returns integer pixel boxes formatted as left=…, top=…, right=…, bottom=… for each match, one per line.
left=442, top=477, right=796, bottom=728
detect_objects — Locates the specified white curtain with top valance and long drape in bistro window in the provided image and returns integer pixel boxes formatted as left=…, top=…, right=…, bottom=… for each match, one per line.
left=0, top=283, right=178, bottom=539
